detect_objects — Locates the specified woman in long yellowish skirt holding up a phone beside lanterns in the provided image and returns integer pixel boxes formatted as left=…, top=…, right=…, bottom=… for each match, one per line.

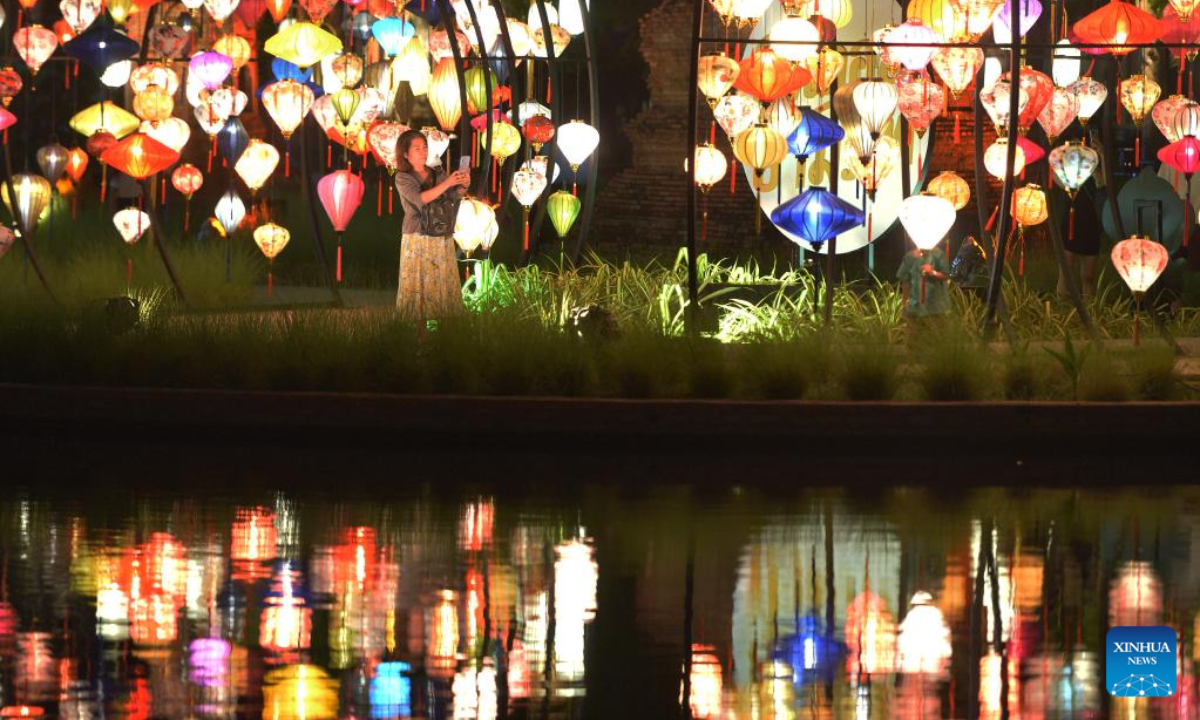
left=396, top=130, right=470, bottom=323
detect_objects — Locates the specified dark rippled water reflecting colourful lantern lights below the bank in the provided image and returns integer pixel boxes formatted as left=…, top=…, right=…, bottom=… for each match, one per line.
left=0, top=484, right=1200, bottom=720
